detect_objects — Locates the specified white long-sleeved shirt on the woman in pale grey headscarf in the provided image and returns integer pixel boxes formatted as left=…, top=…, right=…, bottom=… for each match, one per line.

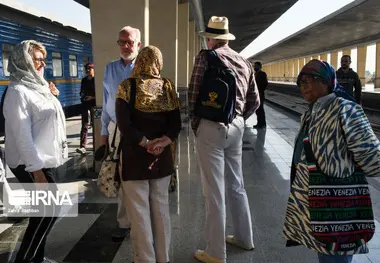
left=3, top=82, right=64, bottom=172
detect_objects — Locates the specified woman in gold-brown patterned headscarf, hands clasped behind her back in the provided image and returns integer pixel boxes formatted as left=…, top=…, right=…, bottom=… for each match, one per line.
left=116, top=46, right=181, bottom=263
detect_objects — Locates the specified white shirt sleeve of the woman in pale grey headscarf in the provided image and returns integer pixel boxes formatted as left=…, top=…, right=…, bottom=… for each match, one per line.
left=3, top=89, right=44, bottom=172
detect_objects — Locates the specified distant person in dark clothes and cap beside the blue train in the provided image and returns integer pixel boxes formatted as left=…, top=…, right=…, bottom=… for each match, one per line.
left=77, top=63, right=95, bottom=154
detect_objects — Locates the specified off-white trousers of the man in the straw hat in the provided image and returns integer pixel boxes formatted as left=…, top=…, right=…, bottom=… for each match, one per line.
left=196, top=117, right=253, bottom=259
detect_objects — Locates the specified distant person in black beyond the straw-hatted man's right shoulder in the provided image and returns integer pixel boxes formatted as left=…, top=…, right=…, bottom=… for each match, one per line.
left=253, top=62, right=268, bottom=129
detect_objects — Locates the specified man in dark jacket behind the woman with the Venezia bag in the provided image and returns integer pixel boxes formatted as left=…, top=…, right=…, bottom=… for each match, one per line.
left=336, top=55, right=362, bottom=104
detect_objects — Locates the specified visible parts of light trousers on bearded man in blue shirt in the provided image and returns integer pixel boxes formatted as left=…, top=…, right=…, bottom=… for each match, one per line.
left=108, top=121, right=131, bottom=228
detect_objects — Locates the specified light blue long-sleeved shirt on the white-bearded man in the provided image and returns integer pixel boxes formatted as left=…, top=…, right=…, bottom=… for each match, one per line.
left=101, top=58, right=135, bottom=135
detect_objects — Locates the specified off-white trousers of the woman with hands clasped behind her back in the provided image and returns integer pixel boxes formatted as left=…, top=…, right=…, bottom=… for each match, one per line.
left=122, top=176, right=171, bottom=263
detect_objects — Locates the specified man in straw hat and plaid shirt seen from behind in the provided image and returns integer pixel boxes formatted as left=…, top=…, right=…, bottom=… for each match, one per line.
left=188, top=16, right=260, bottom=263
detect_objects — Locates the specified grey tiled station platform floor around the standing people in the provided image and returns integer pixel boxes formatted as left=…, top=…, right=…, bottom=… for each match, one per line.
left=0, top=104, right=380, bottom=263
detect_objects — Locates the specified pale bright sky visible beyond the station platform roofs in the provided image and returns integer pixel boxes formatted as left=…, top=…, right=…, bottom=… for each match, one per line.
left=0, top=0, right=375, bottom=74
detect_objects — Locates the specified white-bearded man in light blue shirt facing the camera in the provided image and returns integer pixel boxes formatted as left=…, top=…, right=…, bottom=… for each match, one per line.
left=101, top=26, right=141, bottom=241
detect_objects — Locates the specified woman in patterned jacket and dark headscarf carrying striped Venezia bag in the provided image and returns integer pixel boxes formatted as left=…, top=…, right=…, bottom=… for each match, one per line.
left=283, top=60, right=380, bottom=263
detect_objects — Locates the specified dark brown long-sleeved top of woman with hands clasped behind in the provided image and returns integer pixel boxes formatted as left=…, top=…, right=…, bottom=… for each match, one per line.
left=116, top=99, right=181, bottom=181
